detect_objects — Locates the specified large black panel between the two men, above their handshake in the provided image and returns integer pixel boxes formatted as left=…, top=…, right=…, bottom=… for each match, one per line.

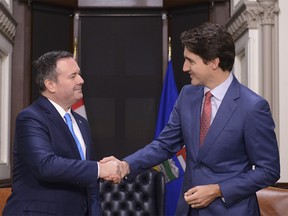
left=79, top=10, right=162, bottom=159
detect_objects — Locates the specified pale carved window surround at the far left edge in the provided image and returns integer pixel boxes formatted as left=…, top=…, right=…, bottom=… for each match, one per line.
left=0, top=0, right=16, bottom=181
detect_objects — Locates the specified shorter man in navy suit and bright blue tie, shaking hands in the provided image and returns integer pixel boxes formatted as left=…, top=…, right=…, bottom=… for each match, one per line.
left=3, top=51, right=119, bottom=216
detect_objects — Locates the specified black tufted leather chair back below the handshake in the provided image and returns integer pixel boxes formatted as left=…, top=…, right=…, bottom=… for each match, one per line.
left=100, top=169, right=165, bottom=216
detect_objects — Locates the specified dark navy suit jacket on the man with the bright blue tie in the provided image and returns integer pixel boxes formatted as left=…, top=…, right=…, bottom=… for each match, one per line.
left=3, top=96, right=101, bottom=216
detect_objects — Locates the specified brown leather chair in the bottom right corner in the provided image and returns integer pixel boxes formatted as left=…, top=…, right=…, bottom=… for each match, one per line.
left=256, top=187, right=288, bottom=216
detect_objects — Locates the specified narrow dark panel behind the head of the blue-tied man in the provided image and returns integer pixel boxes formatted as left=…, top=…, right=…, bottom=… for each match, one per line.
left=31, top=3, right=73, bottom=101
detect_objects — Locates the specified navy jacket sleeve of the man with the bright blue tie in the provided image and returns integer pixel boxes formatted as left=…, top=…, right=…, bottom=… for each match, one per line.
left=15, top=110, right=98, bottom=185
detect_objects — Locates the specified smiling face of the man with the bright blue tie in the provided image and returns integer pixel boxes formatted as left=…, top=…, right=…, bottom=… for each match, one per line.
left=44, top=58, right=84, bottom=111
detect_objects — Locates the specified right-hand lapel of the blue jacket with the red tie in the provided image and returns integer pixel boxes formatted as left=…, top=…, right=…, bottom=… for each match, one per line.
left=198, top=77, right=240, bottom=161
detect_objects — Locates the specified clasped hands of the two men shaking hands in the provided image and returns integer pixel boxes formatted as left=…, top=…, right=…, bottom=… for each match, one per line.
left=99, top=156, right=130, bottom=184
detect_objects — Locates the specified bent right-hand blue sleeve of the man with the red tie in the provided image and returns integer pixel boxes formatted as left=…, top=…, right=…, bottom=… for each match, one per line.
left=220, top=99, right=280, bottom=207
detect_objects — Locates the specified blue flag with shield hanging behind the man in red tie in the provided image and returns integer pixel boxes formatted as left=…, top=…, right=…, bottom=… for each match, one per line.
left=155, top=60, right=186, bottom=216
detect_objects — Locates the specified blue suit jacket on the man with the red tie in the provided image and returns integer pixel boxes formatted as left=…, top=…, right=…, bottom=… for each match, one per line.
left=124, top=77, right=280, bottom=216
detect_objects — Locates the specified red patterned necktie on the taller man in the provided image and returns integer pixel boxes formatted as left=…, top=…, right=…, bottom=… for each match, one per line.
left=200, top=91, right=213, bottom=144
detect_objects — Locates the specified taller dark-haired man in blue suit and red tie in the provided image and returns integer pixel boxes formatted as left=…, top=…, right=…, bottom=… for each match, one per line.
left=103, top=23, right=280, bottom=216
